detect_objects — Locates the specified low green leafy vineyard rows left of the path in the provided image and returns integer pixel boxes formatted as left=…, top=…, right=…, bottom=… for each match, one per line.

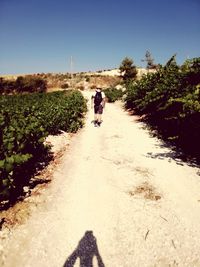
left=0, top=91, right=86, bottom=200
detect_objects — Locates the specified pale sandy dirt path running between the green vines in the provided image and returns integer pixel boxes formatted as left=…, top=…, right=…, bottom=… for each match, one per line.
left=0, top=93, right=200, bottom=267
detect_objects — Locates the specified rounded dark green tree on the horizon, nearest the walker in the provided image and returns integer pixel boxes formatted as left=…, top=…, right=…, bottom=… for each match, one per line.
left=119, top=57, right=137, bottom=83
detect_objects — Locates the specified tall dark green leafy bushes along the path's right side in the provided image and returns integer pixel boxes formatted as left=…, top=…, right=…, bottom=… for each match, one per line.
left=125, top=55, right=200, bottom=161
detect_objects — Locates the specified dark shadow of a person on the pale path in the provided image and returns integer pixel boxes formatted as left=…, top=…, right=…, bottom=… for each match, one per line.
left=63, top=231, right=105, bottom=267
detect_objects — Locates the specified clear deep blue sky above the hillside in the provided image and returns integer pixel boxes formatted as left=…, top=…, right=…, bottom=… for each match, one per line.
left=0, top=0, right=200, bottom=74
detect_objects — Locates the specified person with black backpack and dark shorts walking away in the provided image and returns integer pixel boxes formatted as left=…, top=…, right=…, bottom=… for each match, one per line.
left=91, top=88, right=106, bottom=126
